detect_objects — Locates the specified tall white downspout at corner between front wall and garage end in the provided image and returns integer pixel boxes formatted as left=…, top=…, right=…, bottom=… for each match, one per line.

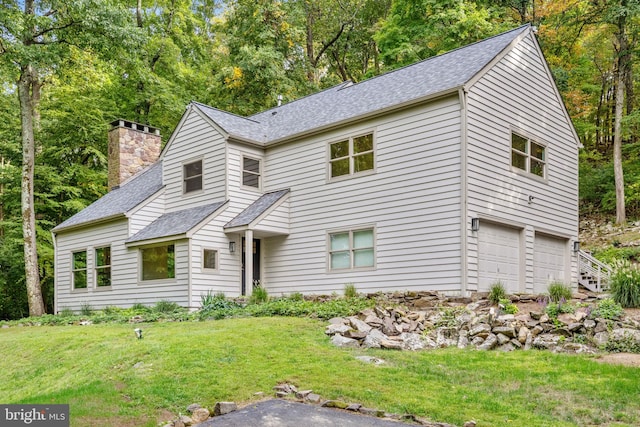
left=458, top=87, right=469, bottom=296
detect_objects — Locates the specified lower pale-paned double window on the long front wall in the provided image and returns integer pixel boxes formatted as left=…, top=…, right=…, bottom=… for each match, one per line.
left=329, top=228, right=375, bottom=270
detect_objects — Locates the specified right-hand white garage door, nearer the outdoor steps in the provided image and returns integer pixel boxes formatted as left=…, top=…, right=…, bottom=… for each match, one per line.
left=533, top=233, right=567, bottom=293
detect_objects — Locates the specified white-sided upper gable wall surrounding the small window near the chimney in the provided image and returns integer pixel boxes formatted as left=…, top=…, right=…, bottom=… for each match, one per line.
left=163, top=109, right=226, bottom=212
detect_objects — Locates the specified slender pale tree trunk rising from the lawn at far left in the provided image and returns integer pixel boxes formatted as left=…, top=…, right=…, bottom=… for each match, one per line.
left=18, top=65, right=45, bottom=316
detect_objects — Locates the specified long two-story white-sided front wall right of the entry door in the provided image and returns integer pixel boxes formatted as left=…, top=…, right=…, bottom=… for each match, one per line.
left=263, top=97, right=461, bottom=294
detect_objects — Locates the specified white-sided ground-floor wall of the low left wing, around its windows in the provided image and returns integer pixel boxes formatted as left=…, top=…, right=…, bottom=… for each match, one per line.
left=55, top=220, right=188, bottom=311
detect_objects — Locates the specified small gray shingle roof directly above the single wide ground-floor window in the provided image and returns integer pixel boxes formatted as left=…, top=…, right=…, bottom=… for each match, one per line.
left=126, top=202, right=225, bottom=243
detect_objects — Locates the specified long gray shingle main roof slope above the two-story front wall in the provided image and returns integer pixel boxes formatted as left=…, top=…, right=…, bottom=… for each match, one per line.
left=193, top=25, right=530, bottom=144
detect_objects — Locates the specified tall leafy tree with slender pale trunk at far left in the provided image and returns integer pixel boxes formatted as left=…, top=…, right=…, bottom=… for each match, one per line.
left=0, top=0, right=139, bottom=316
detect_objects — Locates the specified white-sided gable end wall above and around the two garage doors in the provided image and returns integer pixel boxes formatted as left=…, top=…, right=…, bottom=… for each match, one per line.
left=467, top=35, right=578, bottom=290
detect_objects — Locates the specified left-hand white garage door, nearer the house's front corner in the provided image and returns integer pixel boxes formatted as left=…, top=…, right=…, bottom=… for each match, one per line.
left=478, top=222, right=520, bottom=293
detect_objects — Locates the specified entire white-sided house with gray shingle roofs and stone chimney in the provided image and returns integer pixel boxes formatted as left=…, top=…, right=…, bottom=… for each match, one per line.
left=53, top=26, right=580, bottom=310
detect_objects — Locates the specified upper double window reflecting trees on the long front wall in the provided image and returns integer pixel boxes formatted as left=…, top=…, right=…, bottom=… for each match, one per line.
left=329, top=133, right=374, bottom=178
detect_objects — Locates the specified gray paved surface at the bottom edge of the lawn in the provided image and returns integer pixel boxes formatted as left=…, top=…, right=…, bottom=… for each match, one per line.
left=198, top=399, right=407, bottom=427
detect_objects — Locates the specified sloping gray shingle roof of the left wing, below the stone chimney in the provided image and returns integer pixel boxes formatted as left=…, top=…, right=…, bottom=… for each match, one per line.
left=52, top=161, right=162, bottom=232
